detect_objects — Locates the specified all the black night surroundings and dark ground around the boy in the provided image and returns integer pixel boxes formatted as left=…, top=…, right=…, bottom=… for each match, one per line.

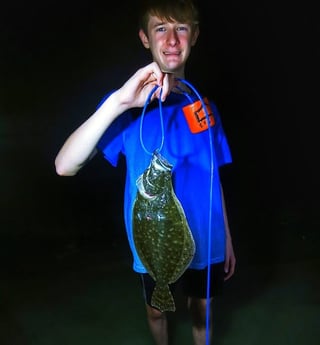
left=0, top=1, right=320, bottom=345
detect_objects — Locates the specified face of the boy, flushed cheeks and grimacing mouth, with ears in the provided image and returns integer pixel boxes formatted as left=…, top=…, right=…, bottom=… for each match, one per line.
left=139, top=16, right=199, bottom=77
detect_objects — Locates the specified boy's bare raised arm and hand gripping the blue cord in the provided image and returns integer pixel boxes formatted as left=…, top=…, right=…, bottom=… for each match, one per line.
left=55, top=62, right=174, bottom=176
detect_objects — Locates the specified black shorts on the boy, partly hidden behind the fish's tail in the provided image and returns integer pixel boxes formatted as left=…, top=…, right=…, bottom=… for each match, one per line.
left=140, top=262, right=225, bottom=305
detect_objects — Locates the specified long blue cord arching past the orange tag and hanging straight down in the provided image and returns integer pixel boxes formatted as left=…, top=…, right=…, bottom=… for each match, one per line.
left=177, top=78, right=214, bottom=345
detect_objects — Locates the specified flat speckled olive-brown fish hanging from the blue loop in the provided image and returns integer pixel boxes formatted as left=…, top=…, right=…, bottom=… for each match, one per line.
left=133, top=152, right=195, bottom=312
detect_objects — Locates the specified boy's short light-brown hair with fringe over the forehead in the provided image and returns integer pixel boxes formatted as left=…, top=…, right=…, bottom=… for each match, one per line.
left=139, top=0, right=199, bottom=35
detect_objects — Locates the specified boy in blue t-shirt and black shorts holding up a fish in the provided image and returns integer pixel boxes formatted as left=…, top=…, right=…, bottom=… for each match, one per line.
left=55, top=0, right=236, bottom=345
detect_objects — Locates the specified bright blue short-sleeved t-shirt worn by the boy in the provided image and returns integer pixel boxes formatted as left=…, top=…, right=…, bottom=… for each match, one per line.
left=98, top=92, right=232, bottom=273
